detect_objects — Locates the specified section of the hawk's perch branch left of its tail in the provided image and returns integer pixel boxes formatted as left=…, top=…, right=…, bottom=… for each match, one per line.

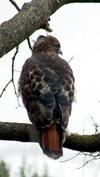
left=0, top=122, right=38, bottom=142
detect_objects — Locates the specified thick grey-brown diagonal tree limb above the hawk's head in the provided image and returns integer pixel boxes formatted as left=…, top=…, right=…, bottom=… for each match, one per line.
left=0, top=0, right=100, bottom=57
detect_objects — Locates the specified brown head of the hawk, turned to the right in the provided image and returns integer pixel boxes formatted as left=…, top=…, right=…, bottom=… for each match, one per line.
left=33, top=35, right=62, bottom=54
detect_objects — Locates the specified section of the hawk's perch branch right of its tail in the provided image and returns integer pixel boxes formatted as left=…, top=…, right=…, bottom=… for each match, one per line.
left=64, top=133, right=100, bottom=152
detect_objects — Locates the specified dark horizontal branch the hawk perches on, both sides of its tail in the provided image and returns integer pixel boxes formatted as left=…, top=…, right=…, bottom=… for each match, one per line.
left=0, top=122, right=100, bottom=152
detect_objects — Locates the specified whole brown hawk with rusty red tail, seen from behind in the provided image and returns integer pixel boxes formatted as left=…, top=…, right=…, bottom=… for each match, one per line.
left=19, top=36, right=74, bottom=159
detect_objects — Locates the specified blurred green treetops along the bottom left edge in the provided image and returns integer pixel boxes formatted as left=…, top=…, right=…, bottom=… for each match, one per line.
left=0, top=160, right=49, bottom=177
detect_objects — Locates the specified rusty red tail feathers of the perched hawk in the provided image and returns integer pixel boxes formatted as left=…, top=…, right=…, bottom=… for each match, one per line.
left=41, top=122, right=63, bottom=159
